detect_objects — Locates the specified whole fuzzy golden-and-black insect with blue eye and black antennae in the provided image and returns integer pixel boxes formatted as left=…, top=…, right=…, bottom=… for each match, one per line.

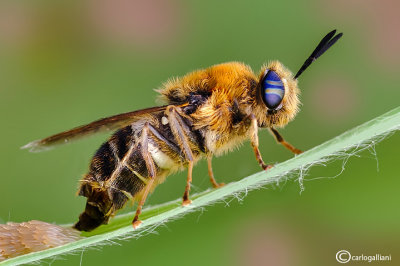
left=18, top=31, right=342, bottom=231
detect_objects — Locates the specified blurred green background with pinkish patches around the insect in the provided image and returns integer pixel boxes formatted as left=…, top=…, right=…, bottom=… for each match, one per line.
left=0, top=0, right=400, bottom=266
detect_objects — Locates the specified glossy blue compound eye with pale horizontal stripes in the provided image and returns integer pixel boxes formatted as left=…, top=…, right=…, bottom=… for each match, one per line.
left=261, top=70, right=285, bottom=110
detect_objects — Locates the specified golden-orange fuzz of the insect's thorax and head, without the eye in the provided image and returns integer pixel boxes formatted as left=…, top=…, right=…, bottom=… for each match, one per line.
left=158, top=61, right=300, bottom=132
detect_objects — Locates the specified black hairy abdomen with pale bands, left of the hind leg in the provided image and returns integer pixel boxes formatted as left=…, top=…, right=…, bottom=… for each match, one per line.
left=75, top=126, right=152, bottom=231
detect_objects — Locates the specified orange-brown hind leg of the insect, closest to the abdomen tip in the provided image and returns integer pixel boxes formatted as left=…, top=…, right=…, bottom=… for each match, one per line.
left=132, top=123, right=156, bottom=229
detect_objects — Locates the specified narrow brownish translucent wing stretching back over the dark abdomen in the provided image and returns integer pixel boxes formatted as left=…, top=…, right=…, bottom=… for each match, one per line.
left=21, top=106, right=167, bottom=152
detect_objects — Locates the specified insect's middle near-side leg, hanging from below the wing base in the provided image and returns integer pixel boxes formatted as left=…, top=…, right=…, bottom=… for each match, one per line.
left=166, top=106, right=194, bottom=206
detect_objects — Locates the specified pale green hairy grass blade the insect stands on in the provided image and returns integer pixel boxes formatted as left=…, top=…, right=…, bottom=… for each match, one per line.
left=0, top=107, right=400, bottom=265
